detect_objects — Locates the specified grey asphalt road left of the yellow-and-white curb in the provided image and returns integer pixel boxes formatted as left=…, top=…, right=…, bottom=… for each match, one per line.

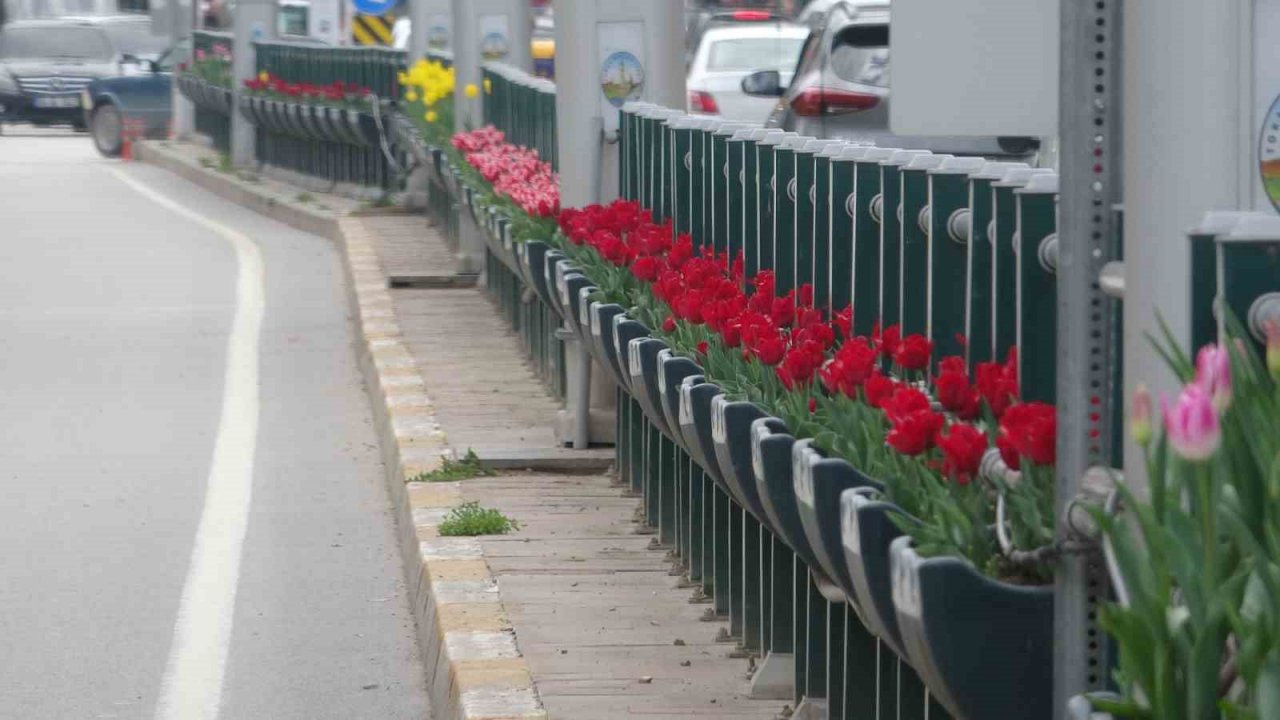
left=0, top=128, right=429, bottom=720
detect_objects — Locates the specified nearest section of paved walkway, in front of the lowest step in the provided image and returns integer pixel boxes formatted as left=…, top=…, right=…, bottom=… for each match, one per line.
left=473, top=474, right=785, bottom=720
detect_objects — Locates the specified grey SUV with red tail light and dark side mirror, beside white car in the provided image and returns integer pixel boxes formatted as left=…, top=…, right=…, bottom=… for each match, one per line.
left=742, top=1, right=1039, bottom=156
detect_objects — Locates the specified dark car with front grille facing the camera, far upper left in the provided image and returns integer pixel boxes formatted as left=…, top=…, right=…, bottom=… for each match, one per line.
left=0, top=15, right=163, bottom=128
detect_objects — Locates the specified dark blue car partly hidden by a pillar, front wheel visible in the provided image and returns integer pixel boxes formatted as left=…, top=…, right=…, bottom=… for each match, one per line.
left=81, top=33, right=176, bottom=158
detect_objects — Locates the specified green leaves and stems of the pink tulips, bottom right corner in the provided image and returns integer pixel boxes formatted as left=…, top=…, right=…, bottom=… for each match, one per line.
left=1094, top=318, right=1280, bottom=720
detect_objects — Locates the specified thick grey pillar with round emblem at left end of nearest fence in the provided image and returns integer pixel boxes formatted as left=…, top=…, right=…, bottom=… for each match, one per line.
left=554, top=0, right=685, bottom=208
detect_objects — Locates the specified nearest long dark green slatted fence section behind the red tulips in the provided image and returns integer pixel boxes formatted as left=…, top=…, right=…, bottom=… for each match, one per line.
left=616, top=105, right=1057, bottom=720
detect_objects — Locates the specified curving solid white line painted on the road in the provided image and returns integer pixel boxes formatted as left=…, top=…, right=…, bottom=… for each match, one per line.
left=111, top=169, right=265, bottom=720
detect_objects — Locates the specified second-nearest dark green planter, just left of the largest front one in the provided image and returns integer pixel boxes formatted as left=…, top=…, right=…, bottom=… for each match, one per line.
left=840, top=488, right=906, bottom=657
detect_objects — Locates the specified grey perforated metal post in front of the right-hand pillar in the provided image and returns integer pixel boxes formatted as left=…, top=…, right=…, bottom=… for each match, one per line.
left=1053, top=0, right=1121, bottom=707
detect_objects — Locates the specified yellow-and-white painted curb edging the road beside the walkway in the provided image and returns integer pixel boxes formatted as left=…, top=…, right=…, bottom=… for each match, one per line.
left=136, top=142, right=547, bottom=720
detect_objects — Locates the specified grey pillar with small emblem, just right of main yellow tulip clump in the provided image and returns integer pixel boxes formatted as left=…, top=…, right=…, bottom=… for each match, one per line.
left=451, top=0, right=534, bottom=131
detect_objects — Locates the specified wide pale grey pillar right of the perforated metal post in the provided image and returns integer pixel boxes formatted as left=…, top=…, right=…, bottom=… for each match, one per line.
left=1123, top=0, right=1257, bottom=476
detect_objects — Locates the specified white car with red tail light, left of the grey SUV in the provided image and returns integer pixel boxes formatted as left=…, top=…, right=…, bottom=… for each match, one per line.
left=686, top=22, right=809, bottom=123
